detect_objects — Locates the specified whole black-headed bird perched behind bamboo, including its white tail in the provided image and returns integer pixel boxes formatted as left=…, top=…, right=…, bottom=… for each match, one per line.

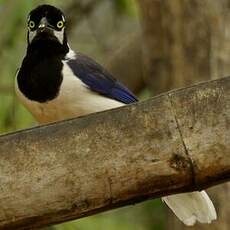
left=15, top=4, right=217, bottom=225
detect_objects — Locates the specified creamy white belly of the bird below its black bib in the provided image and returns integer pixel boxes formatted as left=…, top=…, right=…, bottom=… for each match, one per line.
left=16, top=63, right=124, bottom=123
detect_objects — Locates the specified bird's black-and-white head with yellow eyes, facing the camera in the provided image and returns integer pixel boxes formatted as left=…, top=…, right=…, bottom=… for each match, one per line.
left=28, top=5, right=67, bottom=45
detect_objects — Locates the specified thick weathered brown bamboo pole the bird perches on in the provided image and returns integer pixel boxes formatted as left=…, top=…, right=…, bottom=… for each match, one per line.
left=0, top=77, right=230, bottom=230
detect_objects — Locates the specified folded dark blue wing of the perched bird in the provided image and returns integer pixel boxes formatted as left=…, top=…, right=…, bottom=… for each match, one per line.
left=66, top=53, right=138, bottom=104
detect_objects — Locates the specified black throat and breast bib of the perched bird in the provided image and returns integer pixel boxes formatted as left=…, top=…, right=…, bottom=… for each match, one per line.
left=17, top=40, right=66, bottom=103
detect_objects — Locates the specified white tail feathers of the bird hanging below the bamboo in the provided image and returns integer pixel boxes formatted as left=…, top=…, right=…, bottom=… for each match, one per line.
left=162, top=191, right=216, bottom=226
